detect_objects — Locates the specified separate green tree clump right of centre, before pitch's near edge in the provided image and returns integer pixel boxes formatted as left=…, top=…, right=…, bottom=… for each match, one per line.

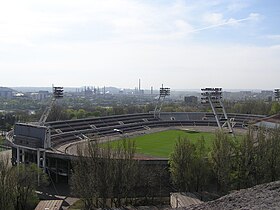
left=169, top=137, right=210, bottom=192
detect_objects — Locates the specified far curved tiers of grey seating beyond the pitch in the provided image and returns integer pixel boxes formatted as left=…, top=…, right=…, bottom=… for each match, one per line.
left=41, top=112, right=264, bottom=147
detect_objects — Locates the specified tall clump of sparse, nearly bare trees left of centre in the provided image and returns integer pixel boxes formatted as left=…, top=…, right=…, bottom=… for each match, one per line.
left=71, top=139, right=137, bottom=209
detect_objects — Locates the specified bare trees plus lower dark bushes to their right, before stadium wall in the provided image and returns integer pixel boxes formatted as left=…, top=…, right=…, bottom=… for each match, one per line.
left=71, top=139, right=168, bottom=209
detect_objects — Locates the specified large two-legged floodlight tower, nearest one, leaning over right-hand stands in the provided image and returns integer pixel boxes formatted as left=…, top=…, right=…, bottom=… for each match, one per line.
left=201, top=88, right=233, bottom=134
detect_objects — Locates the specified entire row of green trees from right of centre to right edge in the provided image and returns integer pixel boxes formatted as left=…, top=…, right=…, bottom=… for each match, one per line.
left=170, top=128, right=280, bottom=197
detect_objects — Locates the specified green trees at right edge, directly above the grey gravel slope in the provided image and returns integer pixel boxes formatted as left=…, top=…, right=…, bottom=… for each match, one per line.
left=211, top=128, right=280, bottom=192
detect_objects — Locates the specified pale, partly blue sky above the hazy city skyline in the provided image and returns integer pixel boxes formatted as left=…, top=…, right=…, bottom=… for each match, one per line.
left=0, top=0, right=280, bottom=90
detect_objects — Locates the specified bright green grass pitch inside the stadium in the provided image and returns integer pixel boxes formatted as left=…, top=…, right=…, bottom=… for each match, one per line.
left=106, top=130, right=215, bottom=157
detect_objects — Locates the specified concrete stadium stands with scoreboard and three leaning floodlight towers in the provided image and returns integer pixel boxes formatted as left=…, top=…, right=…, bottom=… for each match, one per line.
left=3, top=86, right=266, bottom=182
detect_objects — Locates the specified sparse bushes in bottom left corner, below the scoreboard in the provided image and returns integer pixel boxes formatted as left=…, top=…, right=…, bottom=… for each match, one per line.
left=0, top=158, right=47, bottom=210
